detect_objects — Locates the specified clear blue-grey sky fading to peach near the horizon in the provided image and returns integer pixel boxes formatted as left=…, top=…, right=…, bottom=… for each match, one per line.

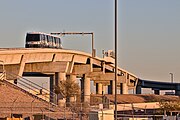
left=0, top=0, right=180, bottom=82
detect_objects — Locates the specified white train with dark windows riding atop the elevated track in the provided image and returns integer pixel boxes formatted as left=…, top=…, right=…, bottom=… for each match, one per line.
left=25, top=32, right=62, bottom=49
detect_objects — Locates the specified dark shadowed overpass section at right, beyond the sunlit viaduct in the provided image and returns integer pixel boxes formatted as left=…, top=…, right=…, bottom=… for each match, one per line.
left=136, top=79, right=180, bottom=96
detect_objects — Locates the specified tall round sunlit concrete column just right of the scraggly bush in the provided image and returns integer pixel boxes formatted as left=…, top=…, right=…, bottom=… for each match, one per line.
left=83, top=75, right=91, bottom=103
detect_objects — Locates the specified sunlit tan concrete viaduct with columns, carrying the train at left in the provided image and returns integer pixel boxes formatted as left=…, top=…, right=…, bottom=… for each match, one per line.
left=0, top=48, right=138, bottom=102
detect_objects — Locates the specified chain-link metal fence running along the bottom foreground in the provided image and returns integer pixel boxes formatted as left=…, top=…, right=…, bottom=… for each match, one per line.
left=0, top=101, right=180, bottom=120
